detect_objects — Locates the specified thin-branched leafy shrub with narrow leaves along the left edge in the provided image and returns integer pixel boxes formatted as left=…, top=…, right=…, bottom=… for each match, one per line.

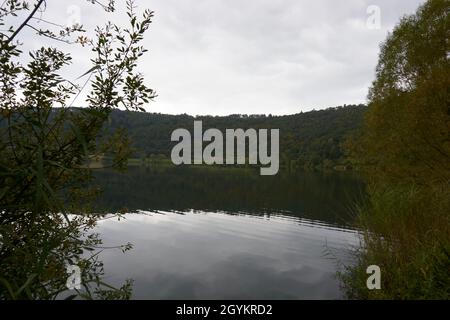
left=0, top=0, right=154, bottom=299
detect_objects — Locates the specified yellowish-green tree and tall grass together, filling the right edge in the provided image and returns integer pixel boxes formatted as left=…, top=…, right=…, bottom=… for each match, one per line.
left=343, top=0, right=450, bottom=299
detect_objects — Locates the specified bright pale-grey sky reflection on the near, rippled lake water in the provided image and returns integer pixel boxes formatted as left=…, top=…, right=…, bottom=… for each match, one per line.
left=96, top=211, right=358, bottom=299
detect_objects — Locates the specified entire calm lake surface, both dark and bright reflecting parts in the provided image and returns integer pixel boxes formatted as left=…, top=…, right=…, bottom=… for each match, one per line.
left=91, top=167, right=364, bottom=299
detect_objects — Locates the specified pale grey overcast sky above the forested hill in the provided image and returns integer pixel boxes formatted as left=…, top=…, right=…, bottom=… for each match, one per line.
left=17, top=0, right=424, bottom=115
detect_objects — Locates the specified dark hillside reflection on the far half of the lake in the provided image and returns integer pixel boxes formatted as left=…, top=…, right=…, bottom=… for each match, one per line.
left=96, top=167, right=363, bottom=225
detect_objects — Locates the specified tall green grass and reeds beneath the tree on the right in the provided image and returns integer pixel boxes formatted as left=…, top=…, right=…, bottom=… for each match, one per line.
left=340, top=184, right=450, bottom=299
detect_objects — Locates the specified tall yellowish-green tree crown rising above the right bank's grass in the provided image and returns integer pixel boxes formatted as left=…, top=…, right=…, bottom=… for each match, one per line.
left=353, top=0, right=450, bottom=184
